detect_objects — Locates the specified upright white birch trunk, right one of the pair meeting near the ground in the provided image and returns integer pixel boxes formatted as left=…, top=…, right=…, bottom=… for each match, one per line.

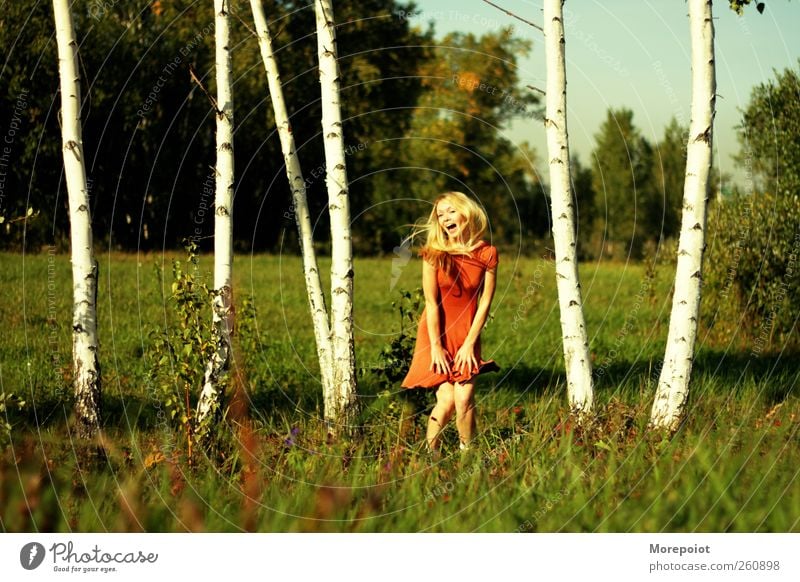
left=314, top=0, right=357, bottom=433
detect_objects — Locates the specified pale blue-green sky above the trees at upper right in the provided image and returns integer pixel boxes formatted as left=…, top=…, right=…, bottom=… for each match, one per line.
left=414, top=0, right=800, bottom=180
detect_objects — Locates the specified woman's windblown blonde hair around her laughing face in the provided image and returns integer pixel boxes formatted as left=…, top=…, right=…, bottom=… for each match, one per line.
left=412, top=192, right=489, bottom=272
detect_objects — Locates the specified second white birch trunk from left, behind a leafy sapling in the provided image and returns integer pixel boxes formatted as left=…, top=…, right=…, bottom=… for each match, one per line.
left=196, top=0, right=233, bottom=427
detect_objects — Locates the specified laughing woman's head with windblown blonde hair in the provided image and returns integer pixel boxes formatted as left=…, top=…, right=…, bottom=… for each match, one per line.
left=425, top=192, right=488, bottom=253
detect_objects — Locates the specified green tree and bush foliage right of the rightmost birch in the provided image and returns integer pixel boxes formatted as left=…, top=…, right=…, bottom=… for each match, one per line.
left=703, top=64, right=800, bottom=353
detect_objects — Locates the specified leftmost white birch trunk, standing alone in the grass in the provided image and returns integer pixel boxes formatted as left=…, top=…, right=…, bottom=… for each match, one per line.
left=53, top=0, right=101, bottom=438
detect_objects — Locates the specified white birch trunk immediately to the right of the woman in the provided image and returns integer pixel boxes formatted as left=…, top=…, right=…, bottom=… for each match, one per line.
left=544, top=0, right=594, bottom=416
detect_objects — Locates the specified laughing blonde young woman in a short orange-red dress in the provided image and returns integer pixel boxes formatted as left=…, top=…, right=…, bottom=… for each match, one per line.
left=402, top=192, right=499, bottom=450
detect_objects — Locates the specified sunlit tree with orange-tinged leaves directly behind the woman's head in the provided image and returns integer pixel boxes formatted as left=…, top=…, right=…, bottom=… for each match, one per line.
left=396, top=29, right=549, bottom=248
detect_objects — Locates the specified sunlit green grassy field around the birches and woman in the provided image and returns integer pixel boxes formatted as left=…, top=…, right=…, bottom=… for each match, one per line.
left=0, top=253, right=800, bottom=532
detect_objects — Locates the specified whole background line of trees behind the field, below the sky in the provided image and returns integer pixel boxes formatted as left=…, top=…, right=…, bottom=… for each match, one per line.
left=0, top=0, right=798, bottom=270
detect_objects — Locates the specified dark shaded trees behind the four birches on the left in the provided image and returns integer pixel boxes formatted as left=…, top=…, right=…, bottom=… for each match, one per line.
left=0, top=0, right=430, bottom=252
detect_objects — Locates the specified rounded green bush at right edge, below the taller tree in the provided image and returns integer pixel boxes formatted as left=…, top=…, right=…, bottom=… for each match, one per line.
left=703, top=194, right=800, bottom=354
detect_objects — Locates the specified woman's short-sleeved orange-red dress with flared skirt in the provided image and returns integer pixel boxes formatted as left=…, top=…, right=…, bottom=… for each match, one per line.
left=402, top=241, right=500, bottom=388
